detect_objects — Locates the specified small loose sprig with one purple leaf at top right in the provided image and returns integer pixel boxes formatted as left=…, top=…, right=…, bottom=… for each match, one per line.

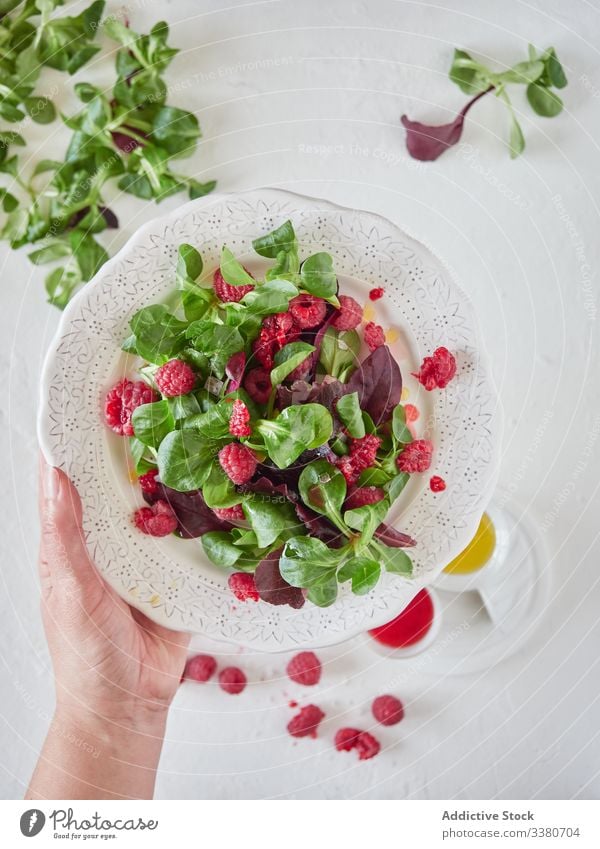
left=401, top=44, right=567, bottom=161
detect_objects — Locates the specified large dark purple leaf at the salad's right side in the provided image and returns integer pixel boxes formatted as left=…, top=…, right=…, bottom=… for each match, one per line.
left=342, top=345, right=402, bottom=425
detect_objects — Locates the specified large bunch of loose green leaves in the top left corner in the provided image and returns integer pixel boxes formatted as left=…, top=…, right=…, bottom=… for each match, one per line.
left=0, top=0, right=215, bottom=309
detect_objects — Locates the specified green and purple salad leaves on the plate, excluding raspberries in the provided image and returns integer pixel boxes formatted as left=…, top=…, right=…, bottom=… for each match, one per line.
left=113, top=221, right=422, bottom=606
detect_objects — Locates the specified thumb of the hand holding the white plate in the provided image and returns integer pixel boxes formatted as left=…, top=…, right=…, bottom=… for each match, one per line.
left=40, top=459, right=104, bottom=607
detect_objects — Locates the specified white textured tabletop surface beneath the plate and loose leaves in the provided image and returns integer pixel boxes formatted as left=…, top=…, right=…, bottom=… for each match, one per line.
left=0, top=0, right=600, bottom=798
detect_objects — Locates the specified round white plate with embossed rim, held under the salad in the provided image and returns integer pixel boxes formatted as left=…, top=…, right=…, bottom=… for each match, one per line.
left=39, top=189, right=500, bottom=651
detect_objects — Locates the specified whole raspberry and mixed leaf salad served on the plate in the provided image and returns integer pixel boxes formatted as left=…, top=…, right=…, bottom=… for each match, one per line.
left=104, top=221, right=456, bottom=608
